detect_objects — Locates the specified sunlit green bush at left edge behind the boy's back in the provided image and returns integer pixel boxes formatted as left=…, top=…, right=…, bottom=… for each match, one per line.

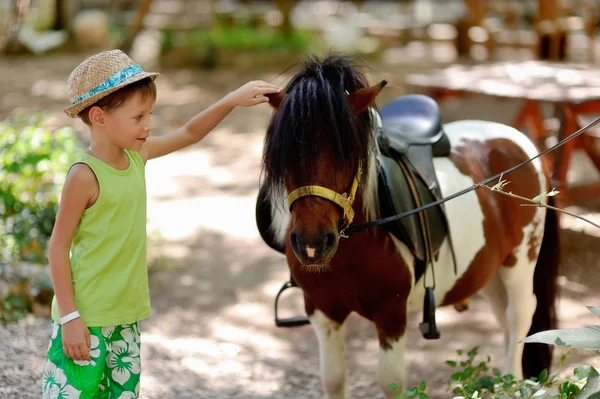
left=0, top=115, right=76, bottom=263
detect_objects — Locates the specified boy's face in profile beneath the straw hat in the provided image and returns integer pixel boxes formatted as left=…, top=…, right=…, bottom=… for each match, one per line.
left=104, top=94, right=154, bottom=151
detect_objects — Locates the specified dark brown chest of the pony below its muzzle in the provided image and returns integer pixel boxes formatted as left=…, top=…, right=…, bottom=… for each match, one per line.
left=286, top=198, right=412, bottom=350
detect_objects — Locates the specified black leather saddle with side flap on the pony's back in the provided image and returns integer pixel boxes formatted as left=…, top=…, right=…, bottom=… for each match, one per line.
left=377, top=94, right=450, bottom=280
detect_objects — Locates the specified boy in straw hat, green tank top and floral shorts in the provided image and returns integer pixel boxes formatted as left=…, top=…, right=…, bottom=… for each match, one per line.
left=42, top=50, right=281, bottom=399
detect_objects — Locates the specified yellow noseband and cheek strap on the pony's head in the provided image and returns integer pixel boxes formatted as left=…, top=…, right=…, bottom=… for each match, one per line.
left=288, top=165, right=362, bottom=237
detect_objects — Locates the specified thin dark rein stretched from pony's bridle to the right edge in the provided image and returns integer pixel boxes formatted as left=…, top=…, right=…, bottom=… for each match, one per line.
left=344, top=117, right=600, bottom=235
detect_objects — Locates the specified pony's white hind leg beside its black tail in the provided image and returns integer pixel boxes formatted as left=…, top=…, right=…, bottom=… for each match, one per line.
left=498, top=253, right=537, bottom=379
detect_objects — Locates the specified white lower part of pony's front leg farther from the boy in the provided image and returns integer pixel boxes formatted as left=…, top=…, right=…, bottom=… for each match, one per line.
left=377, top=337, right=406, bottom=398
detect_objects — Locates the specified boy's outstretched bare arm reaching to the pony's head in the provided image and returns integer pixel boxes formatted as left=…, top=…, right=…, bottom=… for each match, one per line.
left=140, top=80, right=281, bottom=161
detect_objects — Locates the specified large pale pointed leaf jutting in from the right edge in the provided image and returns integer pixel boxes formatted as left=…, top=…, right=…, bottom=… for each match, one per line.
left=521, top=326, right=600, bottom=350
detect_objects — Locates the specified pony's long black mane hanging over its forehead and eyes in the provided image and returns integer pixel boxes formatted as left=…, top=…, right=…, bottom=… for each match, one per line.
left=262, top=56, right=373, bottom=203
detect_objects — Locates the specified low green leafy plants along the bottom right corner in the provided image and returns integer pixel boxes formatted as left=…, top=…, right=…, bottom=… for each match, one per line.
left=391, top=348, right=600, bottom=399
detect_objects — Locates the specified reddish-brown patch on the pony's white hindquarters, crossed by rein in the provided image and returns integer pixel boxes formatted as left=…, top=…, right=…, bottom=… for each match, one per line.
left=443, top=139, right=541, bottom=305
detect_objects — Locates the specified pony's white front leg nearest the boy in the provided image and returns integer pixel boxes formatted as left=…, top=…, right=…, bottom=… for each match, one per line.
left=309, top=309, right=346, bottom=399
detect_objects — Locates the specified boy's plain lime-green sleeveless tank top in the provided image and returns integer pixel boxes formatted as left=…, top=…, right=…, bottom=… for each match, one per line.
left=52, top=150, right=150, bottom=327
